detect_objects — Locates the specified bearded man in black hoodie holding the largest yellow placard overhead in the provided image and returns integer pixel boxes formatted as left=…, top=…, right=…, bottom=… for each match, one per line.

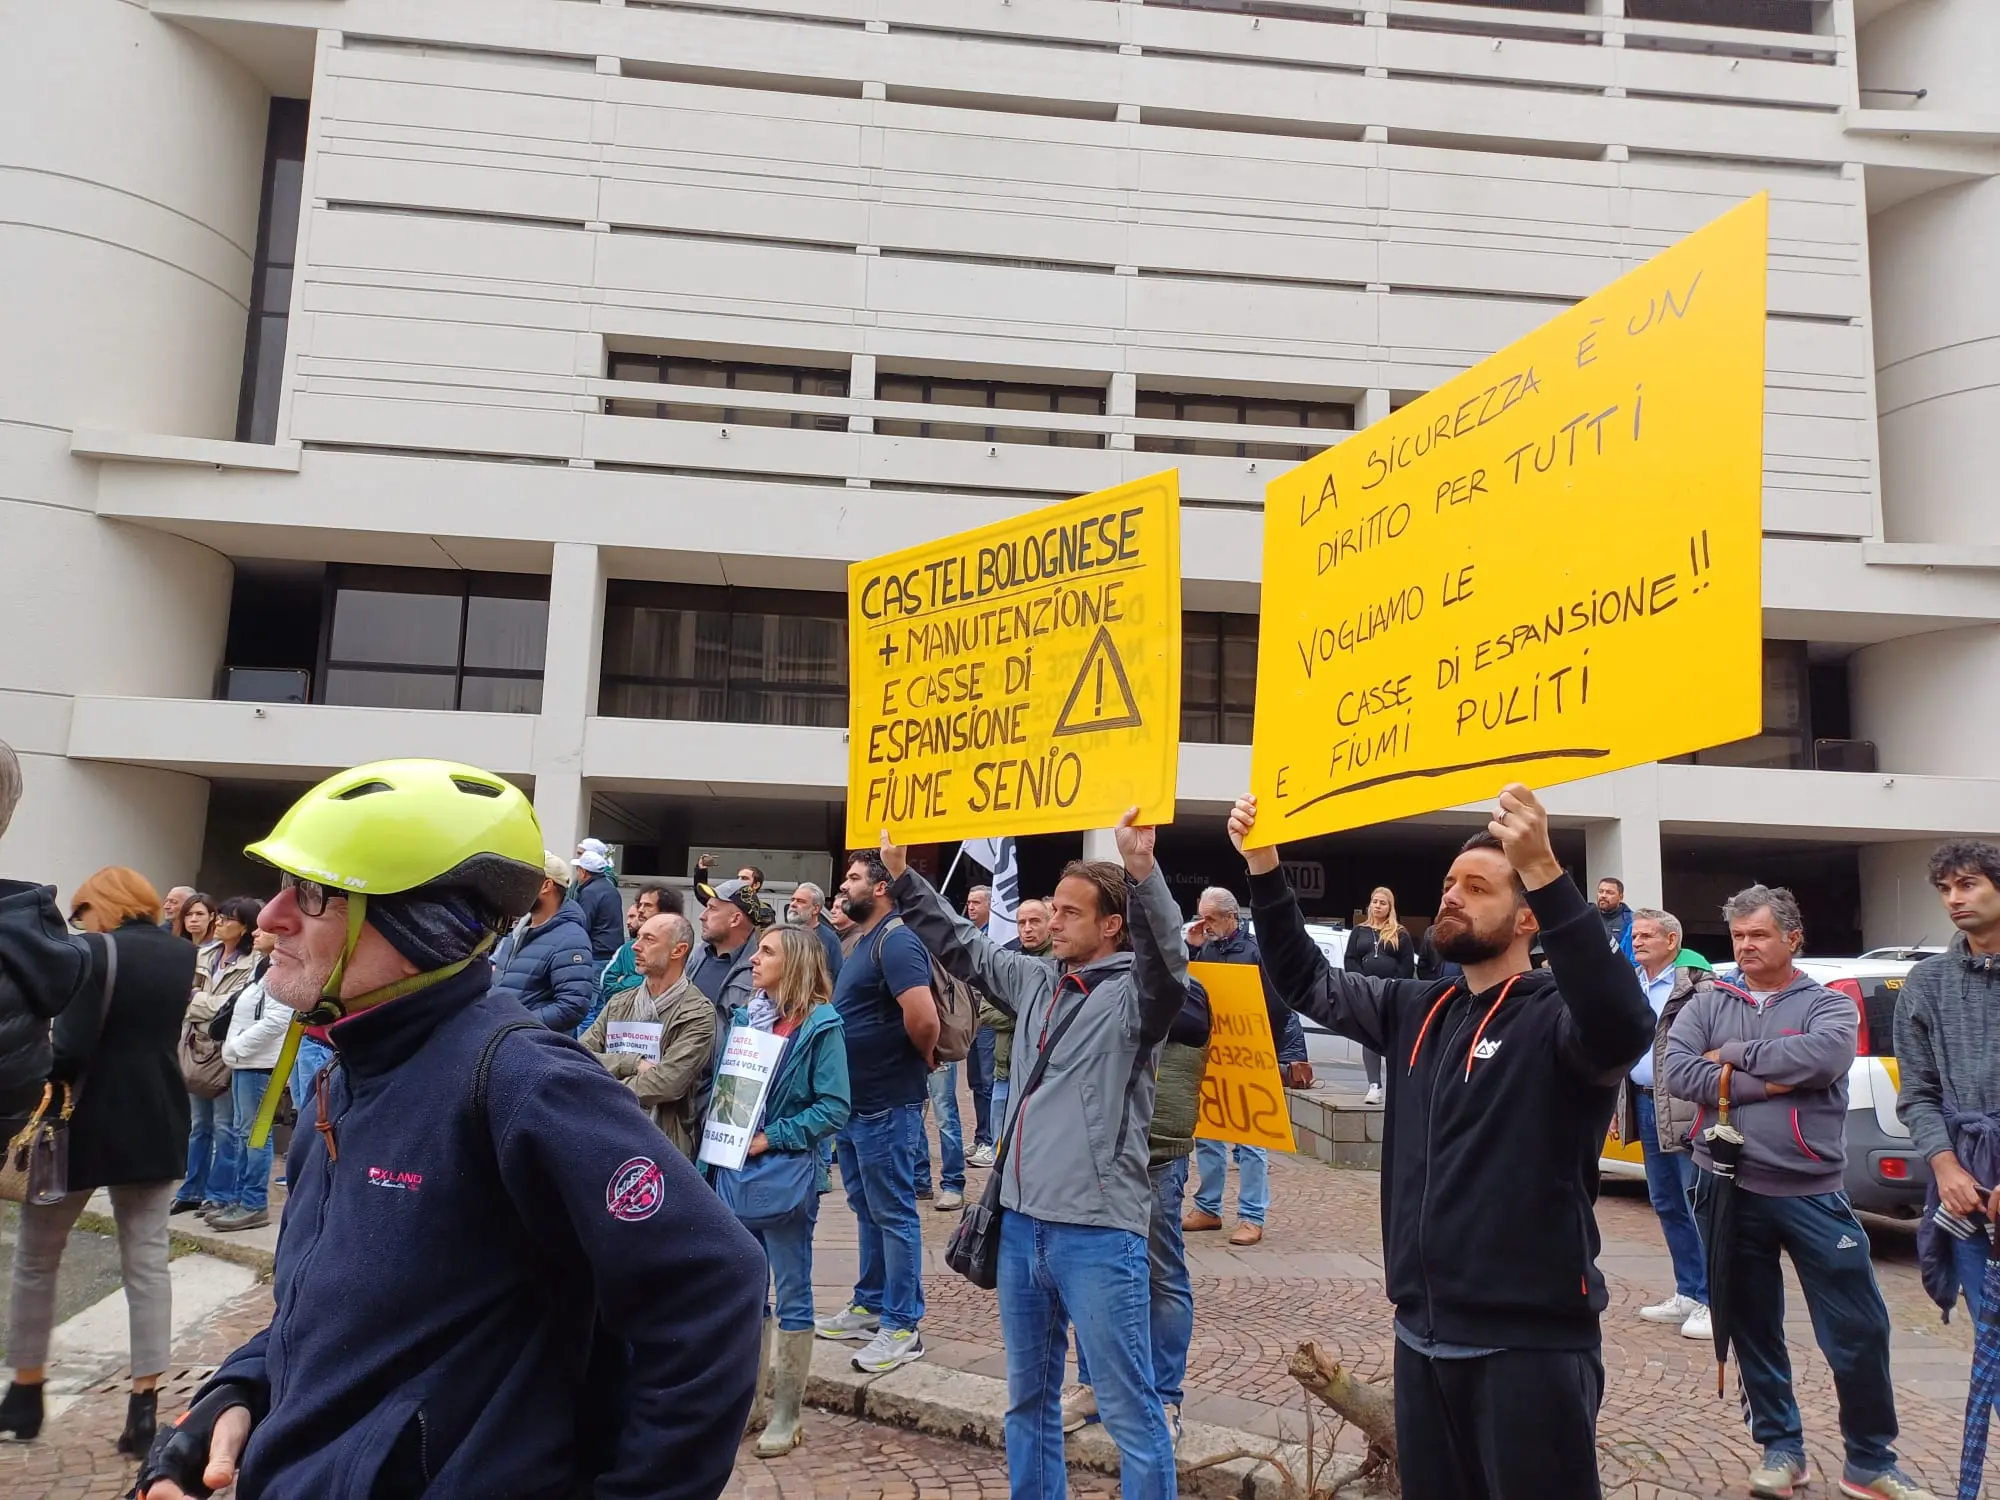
left=1230, top=784, right=1652, bottom=1500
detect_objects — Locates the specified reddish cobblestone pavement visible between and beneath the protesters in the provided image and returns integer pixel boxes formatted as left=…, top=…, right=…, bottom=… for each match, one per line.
left=0, top=1108, right=1970, bottom=1500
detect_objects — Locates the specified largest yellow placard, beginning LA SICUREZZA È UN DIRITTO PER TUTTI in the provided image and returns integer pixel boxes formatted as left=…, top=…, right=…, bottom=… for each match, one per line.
left=1250, top=194, right=1766, bottom=844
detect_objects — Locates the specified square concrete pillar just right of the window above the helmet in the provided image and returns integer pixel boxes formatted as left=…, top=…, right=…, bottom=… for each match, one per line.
left=534, top=542, right=604, bottom=854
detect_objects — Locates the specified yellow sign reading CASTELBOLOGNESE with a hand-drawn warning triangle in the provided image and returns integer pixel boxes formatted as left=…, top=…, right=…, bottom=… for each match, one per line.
left=848, top=470, right=1180, bottom=848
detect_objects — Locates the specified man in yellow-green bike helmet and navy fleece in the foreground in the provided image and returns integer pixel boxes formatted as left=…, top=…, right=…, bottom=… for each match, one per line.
left=134, top=760, right=764, bottom=1500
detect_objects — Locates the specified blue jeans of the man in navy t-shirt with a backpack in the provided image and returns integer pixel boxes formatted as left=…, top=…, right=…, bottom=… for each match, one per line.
left=836, top=1104, right=926, bottom=1332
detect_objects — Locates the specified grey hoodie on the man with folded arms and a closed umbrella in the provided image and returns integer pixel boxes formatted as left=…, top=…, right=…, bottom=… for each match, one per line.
left=1666, top=972, right=1860, bottom=1198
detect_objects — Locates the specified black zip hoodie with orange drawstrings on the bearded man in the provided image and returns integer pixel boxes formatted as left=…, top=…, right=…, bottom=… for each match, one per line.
left=1250, top=870, right=1654, bottom=1350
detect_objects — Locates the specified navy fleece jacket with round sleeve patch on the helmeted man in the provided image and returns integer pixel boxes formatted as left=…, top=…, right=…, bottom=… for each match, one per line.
left=195, top=962, right=766, bottom=1500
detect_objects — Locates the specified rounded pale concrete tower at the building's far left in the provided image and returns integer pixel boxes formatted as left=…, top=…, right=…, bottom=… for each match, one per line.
left=0, top=0, right=270, bottom=894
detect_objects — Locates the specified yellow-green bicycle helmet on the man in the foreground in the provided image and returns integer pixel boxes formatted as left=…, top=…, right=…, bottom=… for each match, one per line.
left=244, top=760, right=542, bottom=926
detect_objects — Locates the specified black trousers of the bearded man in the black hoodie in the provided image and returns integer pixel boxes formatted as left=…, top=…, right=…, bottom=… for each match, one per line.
left=1396, top=1340, right=1604, bottom=1500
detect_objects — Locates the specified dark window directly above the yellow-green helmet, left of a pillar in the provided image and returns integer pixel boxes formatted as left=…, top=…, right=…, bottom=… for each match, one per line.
left=318, top=566, right=548, bottom=714
